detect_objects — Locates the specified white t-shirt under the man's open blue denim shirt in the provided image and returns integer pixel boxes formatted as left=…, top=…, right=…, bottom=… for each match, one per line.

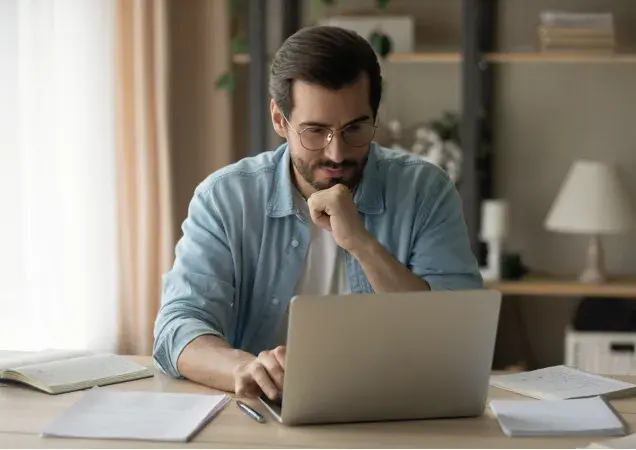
left=276, top=189, right=351, bottom=345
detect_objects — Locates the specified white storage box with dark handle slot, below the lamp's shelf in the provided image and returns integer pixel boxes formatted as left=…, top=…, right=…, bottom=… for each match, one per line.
left=565, top=329, right=636, bottom=375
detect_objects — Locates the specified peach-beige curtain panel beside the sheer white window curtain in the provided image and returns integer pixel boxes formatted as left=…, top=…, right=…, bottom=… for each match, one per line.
left=116, top=0, right=174, bottom=355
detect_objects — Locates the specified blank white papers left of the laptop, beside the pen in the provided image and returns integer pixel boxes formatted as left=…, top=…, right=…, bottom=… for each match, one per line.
left=42, top=388, right=230, bottom=442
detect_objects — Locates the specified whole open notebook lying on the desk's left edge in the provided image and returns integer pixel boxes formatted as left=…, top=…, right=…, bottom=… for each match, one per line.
left=0, top=351, right=153, bottom=394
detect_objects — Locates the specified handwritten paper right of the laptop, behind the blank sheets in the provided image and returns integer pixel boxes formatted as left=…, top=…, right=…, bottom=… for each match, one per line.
left=490, top=365, right=636, bottom=400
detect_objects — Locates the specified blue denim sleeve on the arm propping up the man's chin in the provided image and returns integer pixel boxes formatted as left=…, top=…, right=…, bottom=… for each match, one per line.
left=409, top=170, right=483, bottom=290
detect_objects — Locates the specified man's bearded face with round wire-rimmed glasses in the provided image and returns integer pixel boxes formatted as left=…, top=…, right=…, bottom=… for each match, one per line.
left=272, top=76, right=374, bottom=190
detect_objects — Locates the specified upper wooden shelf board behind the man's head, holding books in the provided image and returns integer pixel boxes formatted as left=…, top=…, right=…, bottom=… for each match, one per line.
left=232, top=52, right=636, bottom=64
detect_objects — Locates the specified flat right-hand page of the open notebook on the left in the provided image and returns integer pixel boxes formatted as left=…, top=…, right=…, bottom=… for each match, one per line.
left=18, top=354, right=150, bottom=387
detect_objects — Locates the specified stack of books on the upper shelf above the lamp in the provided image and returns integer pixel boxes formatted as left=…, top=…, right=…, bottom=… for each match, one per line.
left=538, top=11, right=616, bottom=54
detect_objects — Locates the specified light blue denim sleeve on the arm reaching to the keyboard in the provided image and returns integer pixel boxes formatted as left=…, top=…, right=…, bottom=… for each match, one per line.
left=153, top=191, right=234, bottom=378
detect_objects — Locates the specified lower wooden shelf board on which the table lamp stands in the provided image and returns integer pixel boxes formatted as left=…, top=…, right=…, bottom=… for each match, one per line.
left=485, top=277, right=636, bottom=300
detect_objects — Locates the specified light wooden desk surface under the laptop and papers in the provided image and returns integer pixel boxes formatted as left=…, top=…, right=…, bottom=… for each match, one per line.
left=0, top=358, right=636, bottom=448
